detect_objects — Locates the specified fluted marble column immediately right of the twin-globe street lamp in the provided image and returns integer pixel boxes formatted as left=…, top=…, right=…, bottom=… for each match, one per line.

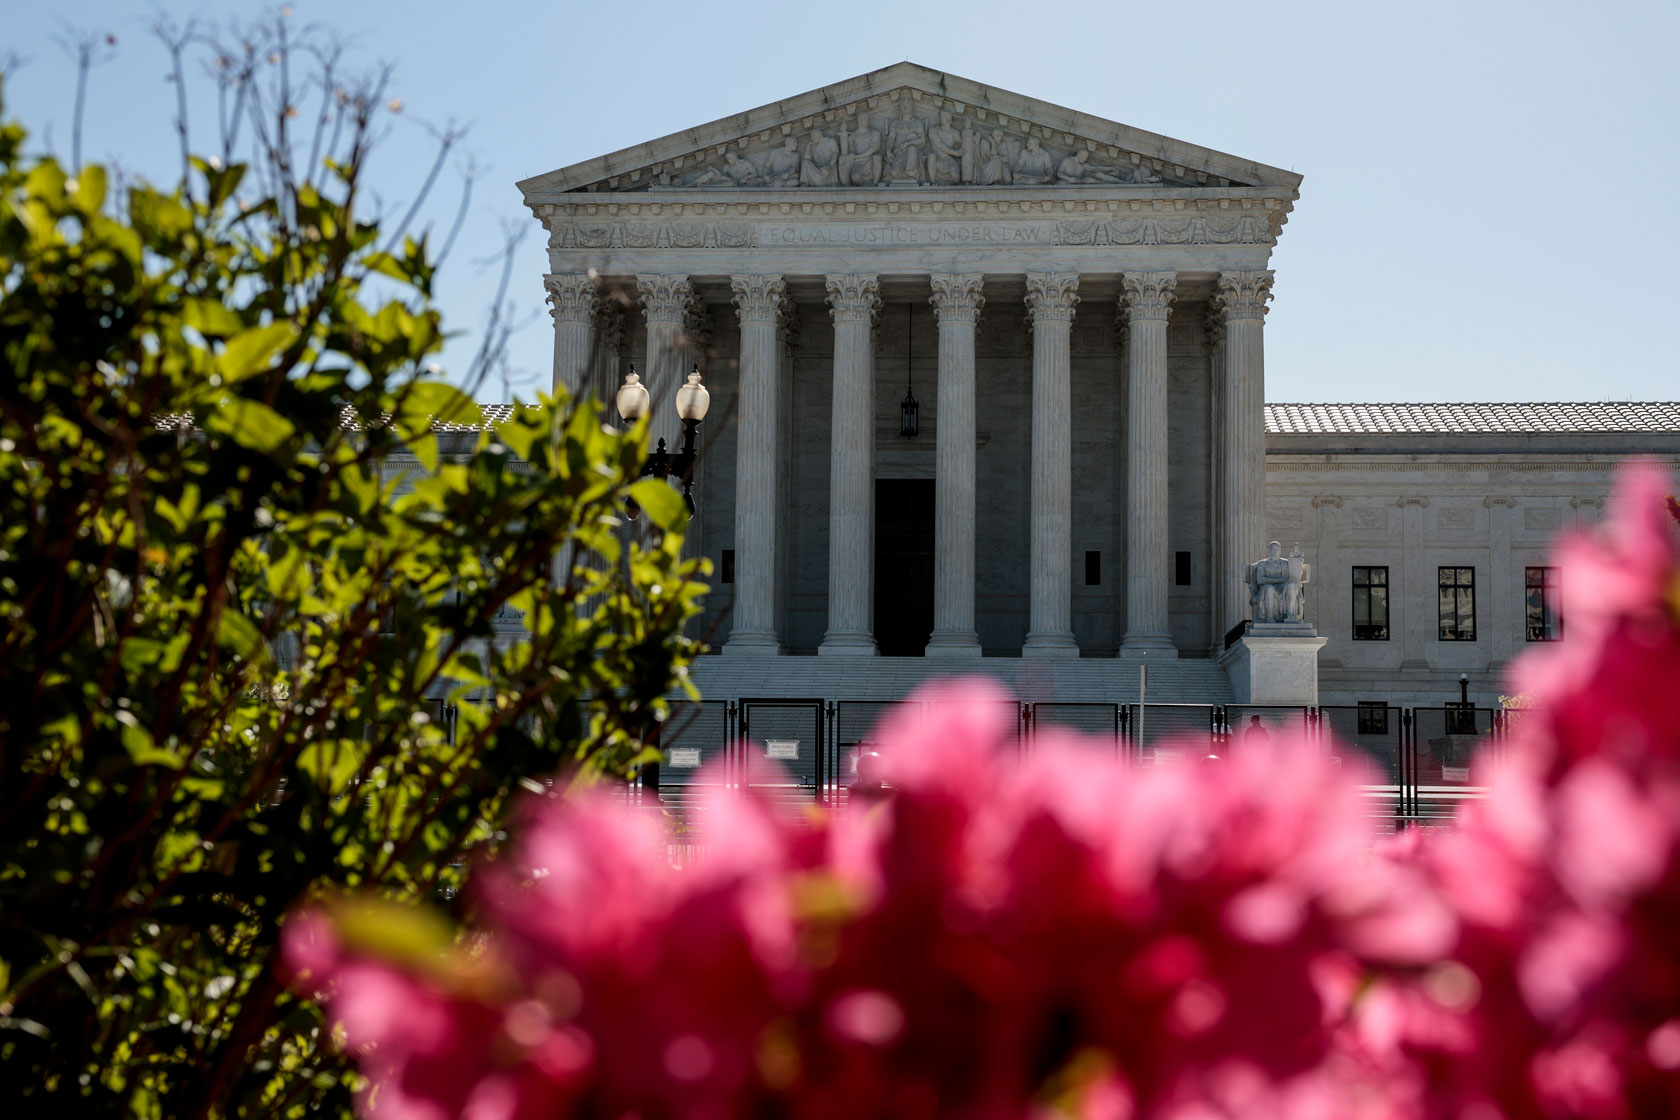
left=724, top=275, right=788, bottom=655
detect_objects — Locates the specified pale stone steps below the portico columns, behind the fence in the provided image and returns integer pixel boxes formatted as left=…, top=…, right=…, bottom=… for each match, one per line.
left=689, top=657, right=1231, bottom=704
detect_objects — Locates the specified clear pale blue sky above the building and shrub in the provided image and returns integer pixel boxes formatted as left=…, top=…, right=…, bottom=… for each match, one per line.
left=13, top=0, right=1680, bottom=401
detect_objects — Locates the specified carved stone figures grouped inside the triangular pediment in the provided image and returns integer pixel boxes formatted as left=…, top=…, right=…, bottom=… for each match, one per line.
left=672, top=101, right=1161, bottom=188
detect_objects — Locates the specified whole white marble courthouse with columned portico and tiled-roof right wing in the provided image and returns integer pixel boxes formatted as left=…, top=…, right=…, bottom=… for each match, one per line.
left=519, top=62, right=1680, bottom=702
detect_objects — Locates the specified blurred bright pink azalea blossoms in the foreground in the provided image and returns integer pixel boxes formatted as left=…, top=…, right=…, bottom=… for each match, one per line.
left=284, top=468, right=1680, bottom=1120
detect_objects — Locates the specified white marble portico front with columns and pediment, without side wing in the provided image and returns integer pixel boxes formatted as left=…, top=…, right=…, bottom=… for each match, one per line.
left=521, top=64, right=1300, bottom=671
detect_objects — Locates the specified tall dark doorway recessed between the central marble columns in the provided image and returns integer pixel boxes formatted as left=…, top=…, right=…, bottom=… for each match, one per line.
left=875, top=479, right=934, bottom=657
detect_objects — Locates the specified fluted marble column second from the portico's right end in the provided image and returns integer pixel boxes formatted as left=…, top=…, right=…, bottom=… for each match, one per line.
left=1121, top=272, right=1178, bottom=658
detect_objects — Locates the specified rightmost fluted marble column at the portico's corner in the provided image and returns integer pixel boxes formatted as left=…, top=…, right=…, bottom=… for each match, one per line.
left=1213, top=269, right=1272, bottom=635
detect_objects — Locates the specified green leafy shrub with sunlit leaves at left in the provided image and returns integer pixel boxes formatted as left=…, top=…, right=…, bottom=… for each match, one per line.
left=0, top=74, right=702, bottom=1118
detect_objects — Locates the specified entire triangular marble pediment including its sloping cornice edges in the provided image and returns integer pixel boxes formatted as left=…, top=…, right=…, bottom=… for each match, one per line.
left=519, top=62, right=1300, bottom=205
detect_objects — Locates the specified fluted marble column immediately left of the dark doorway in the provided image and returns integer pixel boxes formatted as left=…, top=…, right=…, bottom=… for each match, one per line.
left=816, top=275, right=880, bottom=657
